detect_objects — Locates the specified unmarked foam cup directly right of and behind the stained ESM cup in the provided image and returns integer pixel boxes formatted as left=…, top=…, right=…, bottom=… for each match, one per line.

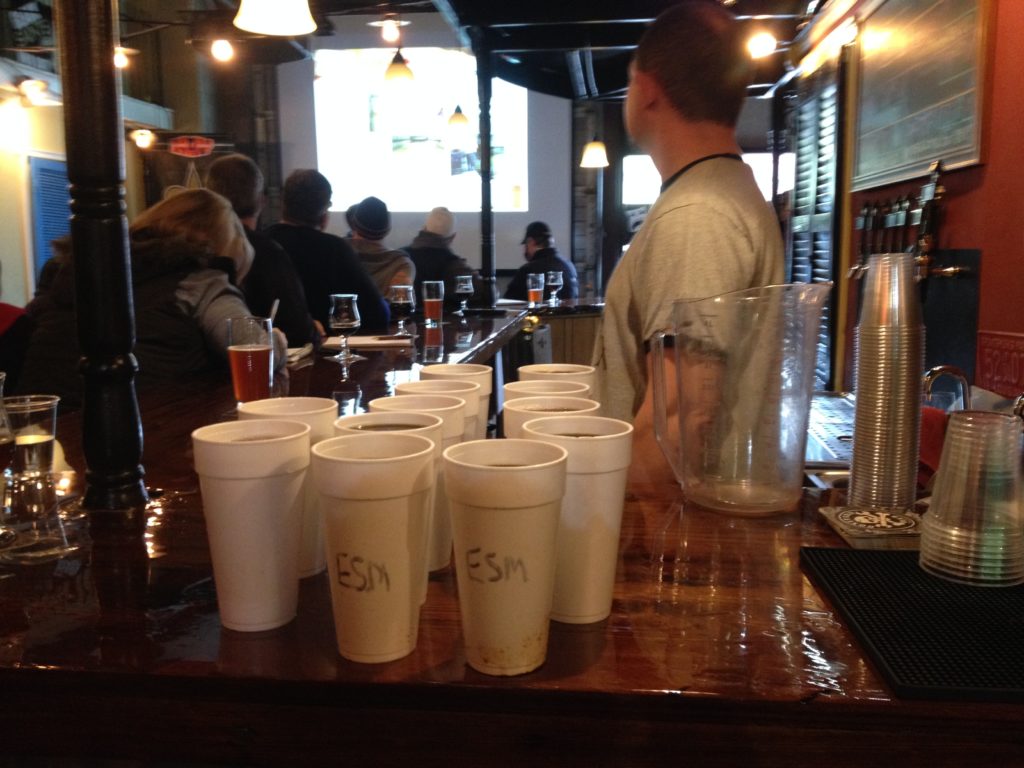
left=522, top=416, right=633, bottom=624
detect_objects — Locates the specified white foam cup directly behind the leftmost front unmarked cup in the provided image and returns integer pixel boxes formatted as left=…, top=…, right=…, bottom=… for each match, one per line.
left=239, top=397, right=338, bottom=579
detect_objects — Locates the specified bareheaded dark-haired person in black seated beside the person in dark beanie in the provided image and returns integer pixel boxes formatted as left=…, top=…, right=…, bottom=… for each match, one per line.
left=264, top=168, right=389, bottom=331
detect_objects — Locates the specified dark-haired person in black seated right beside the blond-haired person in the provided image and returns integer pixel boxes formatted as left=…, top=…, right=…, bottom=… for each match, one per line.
left=206, top=153, right=324, bottom=347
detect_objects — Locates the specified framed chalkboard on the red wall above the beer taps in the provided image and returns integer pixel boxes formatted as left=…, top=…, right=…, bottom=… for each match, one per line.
left=853, top=0, right=988, bottom=190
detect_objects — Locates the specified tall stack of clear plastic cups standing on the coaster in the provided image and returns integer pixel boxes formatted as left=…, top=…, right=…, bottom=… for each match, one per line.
left=849, top=253, right=925, bottom=509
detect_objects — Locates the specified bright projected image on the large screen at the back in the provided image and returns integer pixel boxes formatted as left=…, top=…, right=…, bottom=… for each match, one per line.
left=313, top=48, right=529, bottom=211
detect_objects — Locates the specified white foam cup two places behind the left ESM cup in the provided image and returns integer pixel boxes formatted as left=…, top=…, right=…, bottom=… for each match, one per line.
left=370, top=394, right=466, bottom=570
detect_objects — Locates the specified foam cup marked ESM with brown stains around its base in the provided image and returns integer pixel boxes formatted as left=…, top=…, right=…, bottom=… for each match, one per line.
left=444, top=440, right=567, bottom=675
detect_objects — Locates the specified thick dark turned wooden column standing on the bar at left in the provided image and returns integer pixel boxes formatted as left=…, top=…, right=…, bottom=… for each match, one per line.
left=54, top=0, right=146, bottom=531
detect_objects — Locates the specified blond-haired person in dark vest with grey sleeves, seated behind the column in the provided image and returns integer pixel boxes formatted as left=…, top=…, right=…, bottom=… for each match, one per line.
left=17, top=189, right=287, bottom=408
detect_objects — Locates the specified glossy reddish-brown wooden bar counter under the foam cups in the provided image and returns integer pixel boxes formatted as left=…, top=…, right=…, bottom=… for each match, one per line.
left=0, top=315, right=1024, bottom=766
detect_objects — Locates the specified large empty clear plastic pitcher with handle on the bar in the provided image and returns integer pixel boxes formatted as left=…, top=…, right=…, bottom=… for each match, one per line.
left=653, top=283, right=831, bottom=516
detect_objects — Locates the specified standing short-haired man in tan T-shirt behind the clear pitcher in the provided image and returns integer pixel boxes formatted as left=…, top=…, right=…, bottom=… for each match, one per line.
left=593, top=0, right=783, bottom=421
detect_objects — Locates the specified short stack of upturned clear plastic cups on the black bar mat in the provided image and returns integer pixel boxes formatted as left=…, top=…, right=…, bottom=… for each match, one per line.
left=920, top=411, right=1024, bottom=587
